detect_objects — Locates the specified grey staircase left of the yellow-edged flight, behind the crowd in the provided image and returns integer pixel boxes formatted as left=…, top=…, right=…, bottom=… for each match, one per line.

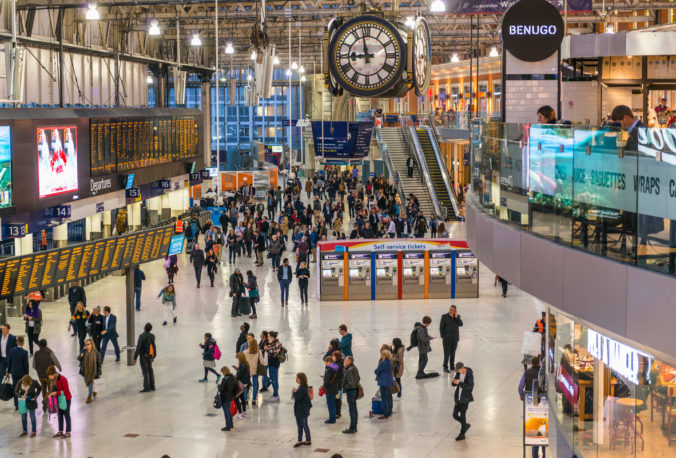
left=380, top=127, right=434, bottom=219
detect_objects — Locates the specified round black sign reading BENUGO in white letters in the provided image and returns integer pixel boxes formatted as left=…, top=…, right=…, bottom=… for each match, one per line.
left=502, top=0, right=563, bottom=62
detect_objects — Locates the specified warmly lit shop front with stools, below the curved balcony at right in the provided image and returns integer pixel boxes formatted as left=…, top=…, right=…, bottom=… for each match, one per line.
left=547, top=308, right=676, bottom=458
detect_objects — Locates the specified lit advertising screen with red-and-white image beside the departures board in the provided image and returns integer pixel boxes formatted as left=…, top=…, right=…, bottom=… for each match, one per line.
left=37, top=126, right=78, bottom=198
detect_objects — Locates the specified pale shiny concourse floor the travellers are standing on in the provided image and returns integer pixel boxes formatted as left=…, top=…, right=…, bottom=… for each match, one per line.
left=0, top=223, right=544, bottom=458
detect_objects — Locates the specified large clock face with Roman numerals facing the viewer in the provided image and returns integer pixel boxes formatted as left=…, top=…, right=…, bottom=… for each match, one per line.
left=329, top=16, right=405, bottom=97
